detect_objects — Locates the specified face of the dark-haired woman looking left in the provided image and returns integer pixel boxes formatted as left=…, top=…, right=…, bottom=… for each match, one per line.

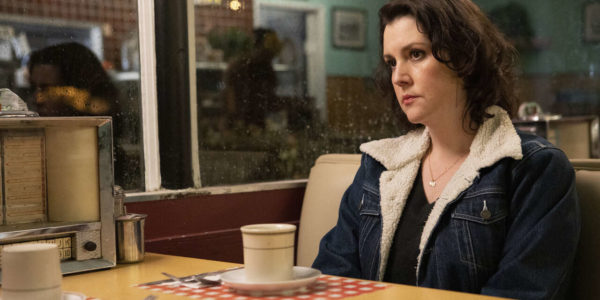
left=383, top=16, right=466, bottom=127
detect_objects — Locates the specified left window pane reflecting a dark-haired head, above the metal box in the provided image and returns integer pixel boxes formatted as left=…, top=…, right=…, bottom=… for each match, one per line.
left=0, top=0, right=143, bottom=190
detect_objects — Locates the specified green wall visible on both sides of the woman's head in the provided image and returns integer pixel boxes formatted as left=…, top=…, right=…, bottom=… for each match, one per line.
left=263, top=0, right=600, bottom=77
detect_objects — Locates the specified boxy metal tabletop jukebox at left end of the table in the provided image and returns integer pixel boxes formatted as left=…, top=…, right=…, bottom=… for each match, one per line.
left=0, top=117, right=116, bottom=274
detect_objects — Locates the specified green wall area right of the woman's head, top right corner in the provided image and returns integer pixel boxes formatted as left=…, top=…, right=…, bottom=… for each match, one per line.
left=474, top=0, right=600, bottom=76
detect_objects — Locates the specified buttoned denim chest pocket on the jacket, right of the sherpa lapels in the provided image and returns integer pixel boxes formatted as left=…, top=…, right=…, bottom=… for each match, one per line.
left=451, top=188, right=508, bottom=273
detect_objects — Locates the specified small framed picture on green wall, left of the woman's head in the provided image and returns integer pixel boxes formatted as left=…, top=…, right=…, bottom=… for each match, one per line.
left=331, top=7, right=367, bottom=49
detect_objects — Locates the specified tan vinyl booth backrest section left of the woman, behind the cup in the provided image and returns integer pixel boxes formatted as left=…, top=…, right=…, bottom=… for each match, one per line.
left=296, top=154, right=360, bottom=266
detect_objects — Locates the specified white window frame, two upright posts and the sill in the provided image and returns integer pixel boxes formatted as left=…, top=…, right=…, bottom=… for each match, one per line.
left=134, top=0, right=308, bottom=197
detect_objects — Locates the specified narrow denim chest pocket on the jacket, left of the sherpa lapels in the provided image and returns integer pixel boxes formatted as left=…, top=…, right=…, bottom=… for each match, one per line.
left=358, top=188, right=381, bottom=280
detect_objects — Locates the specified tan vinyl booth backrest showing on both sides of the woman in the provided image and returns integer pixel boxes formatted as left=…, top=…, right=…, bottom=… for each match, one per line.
left=297, top=154, right=600, bottom=299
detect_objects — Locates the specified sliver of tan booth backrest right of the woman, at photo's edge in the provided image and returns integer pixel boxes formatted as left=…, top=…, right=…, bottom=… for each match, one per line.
left=568, top=159, right=600, bottom=299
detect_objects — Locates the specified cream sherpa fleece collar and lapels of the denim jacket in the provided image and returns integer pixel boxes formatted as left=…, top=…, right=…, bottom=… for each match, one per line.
left=360, top=106, right=523, bottom=280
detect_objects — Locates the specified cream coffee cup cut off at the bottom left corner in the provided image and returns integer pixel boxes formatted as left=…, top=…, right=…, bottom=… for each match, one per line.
left=2, top=243, right=62, bottom=300
